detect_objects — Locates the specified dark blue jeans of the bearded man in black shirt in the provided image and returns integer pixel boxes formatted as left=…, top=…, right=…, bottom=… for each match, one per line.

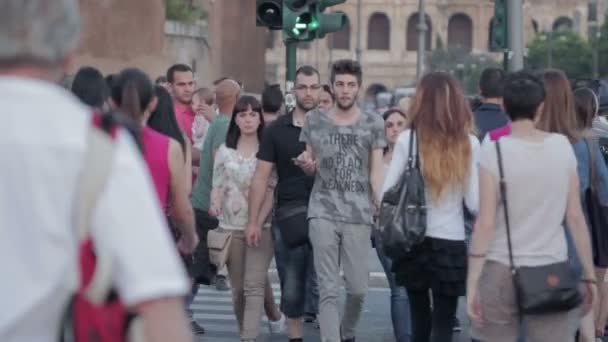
left=272, top=225, right=312, bottom=318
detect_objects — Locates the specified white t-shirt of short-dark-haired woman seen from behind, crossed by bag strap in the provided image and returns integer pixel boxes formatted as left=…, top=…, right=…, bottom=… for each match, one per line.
left=480, top=134, right=577, bottom=266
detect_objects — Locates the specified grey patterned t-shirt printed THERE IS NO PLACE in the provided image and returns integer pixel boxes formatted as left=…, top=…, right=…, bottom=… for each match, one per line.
left=300, top=110, right=386, bottom=224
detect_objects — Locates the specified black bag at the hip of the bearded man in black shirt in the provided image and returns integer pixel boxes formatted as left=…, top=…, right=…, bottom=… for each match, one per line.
left=274, top=201, right=309, bottom=248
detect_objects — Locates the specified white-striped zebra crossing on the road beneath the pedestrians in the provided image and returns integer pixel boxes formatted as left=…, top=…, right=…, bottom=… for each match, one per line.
left=190, top=283, right=281, bottom=342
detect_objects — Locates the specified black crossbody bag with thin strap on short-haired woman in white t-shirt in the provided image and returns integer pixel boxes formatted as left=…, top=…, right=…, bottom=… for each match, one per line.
left=496, top=140, right=582, bottom=317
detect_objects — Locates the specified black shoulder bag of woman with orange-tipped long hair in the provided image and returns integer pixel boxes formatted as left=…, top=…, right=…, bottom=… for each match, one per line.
left=379, top=130, right=426, bottom=260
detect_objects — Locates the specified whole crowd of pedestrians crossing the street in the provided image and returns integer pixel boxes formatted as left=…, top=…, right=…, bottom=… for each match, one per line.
left=5, top=0, right=608, bottom=342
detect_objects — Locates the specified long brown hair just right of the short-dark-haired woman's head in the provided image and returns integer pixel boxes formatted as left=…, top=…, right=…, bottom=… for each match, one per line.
left=536, top=69, right=580, bottom=143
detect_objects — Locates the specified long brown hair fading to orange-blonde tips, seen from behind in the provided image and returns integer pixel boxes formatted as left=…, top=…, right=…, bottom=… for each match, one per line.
left=408, top=72, right=473, bottom=199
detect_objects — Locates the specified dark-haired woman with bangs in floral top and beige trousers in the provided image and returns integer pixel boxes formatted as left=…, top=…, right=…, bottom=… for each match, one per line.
left=209, top=96, right=274, bottom=341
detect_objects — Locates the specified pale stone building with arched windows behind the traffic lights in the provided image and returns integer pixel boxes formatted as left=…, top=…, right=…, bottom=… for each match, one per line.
left=266, top=0, right=605, bottom=94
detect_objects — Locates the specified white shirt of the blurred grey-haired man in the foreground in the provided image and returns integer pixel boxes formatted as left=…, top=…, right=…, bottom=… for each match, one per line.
left=0, top=77, right=188, bottom=342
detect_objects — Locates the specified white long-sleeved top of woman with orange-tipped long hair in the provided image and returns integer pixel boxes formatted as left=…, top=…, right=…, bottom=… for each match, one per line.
left=382, top=129, right=479, bottom=241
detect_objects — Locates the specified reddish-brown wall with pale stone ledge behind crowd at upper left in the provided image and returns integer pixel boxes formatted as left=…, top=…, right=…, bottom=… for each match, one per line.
left=71, top=0, right=214, bottom=85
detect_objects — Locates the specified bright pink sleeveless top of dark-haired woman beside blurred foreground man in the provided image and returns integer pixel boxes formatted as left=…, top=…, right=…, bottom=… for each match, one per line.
left=142, top=127, right=171, bottom=209
